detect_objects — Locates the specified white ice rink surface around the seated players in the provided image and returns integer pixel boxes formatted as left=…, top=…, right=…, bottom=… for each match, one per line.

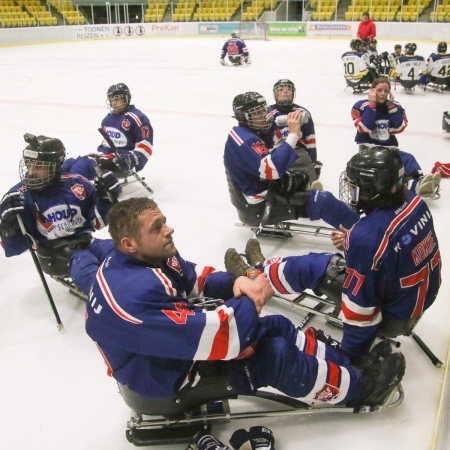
left=0, top=37, right=450, bottom=450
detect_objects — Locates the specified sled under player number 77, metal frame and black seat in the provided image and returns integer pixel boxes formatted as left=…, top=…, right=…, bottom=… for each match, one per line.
left=273, top=292, right=444, bottom=368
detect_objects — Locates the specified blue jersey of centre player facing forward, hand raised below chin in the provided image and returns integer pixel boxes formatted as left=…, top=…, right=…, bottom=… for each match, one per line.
left=267, top=104, right=317, bottom=162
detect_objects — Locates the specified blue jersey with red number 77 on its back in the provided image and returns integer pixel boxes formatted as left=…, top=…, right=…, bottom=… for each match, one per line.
left=342, top=191, right=441, bottom=356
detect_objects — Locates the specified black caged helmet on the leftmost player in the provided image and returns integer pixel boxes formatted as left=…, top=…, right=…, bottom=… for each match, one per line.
left=19, top=133, right=66, bottom=191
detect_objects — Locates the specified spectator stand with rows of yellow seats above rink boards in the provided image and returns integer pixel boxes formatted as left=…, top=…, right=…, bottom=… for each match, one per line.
left=0, top=0, right=450, bottom=28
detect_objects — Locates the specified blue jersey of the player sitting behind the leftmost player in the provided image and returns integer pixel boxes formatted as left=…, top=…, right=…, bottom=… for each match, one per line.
left=97, top=105, right=153, bottom=171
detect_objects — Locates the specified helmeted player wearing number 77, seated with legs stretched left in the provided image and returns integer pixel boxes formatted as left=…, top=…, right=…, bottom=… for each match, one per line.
left=225, top=146, right=441, bottom=361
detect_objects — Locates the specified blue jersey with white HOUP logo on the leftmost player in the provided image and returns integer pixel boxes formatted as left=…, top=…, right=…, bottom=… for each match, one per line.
left=2, top=173, right=106, bottom=257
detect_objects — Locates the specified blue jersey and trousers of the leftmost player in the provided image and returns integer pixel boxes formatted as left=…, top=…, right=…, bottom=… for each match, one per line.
left=2, top=165, right=112, bottom=292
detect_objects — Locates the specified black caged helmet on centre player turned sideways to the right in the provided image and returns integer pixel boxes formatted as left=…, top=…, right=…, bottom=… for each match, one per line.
left=233, top=92, right=271, bottom=131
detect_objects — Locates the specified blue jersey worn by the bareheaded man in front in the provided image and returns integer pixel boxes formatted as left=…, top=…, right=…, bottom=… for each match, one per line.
left=86, top=252, right=259, bottom=397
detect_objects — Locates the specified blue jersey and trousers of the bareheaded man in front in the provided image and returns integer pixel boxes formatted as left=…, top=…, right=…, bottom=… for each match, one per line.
left=86, top=251, right=360, bottom=404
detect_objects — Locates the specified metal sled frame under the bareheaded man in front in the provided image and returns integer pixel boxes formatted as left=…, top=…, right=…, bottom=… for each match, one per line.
left=122, top=384, right=404, bottom=446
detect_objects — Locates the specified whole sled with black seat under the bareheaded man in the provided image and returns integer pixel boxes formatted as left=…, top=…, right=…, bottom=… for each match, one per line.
left=118, top=368, right=404, bottom=446
